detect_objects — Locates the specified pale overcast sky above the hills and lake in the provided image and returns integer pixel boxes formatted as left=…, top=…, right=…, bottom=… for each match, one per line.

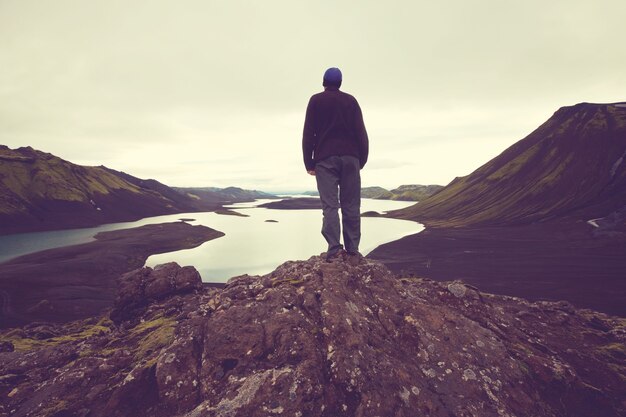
left=0, top=0, right=626, bottom=191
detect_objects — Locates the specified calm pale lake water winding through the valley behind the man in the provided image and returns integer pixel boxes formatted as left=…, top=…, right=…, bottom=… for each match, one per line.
left=0, top=199, right=423, bottom=282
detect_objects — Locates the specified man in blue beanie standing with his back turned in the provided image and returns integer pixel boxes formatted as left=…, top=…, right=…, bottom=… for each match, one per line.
left=302, top=68, right=369, bottom=261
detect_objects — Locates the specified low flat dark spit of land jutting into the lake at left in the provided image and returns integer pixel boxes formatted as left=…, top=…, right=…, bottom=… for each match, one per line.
left=0, top=222, right=224, bottom=327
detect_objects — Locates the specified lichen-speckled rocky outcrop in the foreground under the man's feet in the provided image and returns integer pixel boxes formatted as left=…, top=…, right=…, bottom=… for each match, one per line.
left=0, top=257, right=626, bottom=417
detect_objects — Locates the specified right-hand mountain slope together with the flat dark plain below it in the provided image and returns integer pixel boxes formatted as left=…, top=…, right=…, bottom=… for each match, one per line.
left=368, top=103, right=626, bottom=316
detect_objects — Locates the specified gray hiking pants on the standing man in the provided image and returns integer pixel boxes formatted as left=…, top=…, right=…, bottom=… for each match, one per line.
left=315, top=155, right=361, bottom=254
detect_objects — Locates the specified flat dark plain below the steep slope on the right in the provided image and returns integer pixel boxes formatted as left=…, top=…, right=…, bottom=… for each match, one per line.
left=367, top=221, right=626, bottom=317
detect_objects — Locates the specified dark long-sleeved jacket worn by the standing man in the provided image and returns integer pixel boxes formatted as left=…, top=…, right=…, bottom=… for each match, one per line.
left=302, top=87, right=369, bottom=171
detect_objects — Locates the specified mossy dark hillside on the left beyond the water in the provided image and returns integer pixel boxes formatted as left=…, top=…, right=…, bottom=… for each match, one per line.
left=0, top=146, right=210, bottom=234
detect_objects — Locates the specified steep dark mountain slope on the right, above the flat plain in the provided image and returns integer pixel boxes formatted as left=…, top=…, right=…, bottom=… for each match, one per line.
left=393, top=103, right=626, bottom=227
